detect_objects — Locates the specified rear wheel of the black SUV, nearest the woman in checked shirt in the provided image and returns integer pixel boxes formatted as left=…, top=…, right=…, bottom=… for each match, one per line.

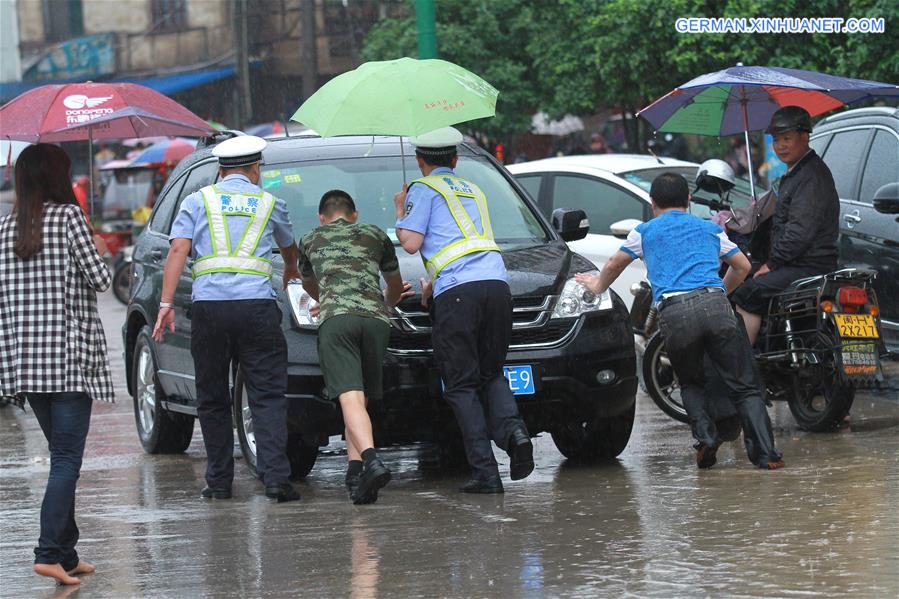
left=132, top=326, right=194, bottom=453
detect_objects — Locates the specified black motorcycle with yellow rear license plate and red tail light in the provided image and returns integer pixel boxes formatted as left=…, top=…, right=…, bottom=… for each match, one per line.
left=631, top=166, right=886, bottom=432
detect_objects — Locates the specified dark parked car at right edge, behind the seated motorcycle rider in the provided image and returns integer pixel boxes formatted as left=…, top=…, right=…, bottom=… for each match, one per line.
left=810, top=107, right=899, bottom=353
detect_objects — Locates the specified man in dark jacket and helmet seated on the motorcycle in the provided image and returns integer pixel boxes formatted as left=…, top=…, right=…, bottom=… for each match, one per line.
left=732, top=106, right=840, bottom=345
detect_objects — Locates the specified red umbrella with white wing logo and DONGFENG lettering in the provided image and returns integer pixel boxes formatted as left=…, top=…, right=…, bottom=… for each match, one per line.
left=0, top=82, right=214, bottom=214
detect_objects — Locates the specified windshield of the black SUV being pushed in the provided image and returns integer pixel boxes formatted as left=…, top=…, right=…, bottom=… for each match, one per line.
left=262, top=156, right=547, bottom=247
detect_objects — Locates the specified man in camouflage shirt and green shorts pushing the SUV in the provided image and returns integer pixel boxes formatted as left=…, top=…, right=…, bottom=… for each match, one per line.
left=300, top=189, right=411, bottom=504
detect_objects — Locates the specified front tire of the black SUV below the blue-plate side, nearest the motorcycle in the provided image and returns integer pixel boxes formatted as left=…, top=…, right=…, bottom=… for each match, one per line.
left=552, top=401, right=637, bottom=462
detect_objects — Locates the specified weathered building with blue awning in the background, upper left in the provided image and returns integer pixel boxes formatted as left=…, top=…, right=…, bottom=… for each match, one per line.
left=7, top=0, right=407, bottom=127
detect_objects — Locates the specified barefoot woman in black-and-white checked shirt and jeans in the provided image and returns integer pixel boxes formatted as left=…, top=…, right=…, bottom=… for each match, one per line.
left=0, top=144, right=113, bottom=584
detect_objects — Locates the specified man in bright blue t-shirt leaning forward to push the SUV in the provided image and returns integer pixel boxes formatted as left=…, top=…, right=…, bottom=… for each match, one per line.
left=576, top=173, right=784, bottom=470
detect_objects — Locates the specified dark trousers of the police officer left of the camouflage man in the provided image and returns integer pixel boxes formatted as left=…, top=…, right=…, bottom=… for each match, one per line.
left=190, top=300, right=290, bottom=489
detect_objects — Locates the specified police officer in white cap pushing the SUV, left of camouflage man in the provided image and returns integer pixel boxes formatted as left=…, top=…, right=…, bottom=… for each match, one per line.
left=153, top=136, right=300, bottom=502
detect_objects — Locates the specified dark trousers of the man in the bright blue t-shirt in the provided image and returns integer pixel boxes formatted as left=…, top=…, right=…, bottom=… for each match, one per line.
left=660, top=293, right=781, bottom=465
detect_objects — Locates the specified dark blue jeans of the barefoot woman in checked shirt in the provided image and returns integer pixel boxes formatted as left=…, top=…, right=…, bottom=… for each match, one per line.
left=26, top=393, right=93, bottom=570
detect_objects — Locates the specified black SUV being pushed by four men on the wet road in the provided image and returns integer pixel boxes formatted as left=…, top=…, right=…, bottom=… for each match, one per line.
left=122, top=136, right=637, bottom=478
